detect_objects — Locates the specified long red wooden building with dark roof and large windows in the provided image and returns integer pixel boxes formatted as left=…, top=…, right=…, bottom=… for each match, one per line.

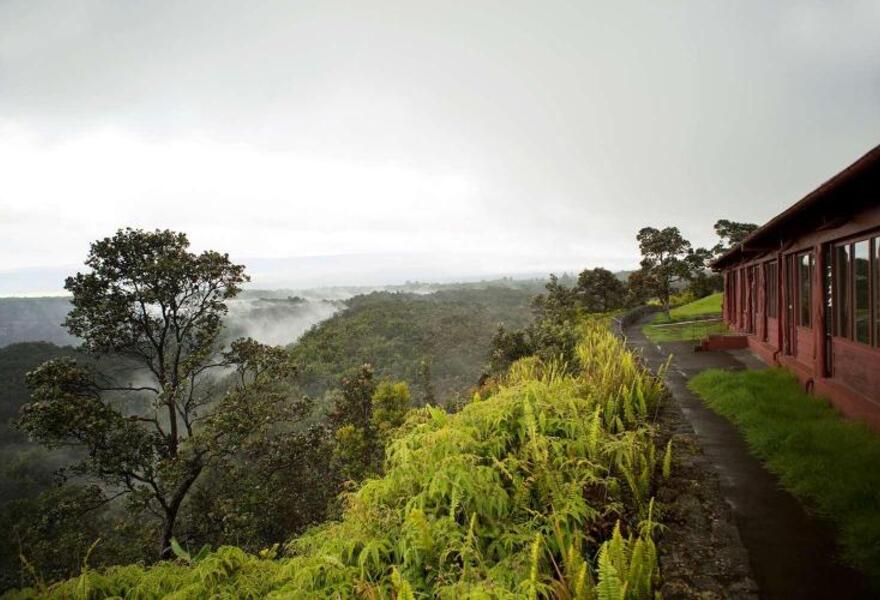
left=714, top=146, right=880, bottom=430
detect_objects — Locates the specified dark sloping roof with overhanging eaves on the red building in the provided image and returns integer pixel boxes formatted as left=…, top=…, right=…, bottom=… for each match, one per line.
left=712, top=145, right=880, bottom=270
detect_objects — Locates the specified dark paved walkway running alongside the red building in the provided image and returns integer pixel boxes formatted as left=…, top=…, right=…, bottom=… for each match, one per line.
left=625, top=323, right=870, bottom=599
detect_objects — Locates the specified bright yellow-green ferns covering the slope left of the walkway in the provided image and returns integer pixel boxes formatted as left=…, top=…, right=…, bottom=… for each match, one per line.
left=7, top=320, right=669, bottom=600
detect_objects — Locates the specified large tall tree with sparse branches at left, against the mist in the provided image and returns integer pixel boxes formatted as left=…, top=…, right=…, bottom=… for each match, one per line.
left=19, top=229, right=300, bottom=558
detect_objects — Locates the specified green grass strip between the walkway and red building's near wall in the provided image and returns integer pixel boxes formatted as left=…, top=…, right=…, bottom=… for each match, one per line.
left=690, top=369, right=880, bottom=589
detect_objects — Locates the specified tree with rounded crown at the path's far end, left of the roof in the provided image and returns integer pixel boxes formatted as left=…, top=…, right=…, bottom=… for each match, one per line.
left=636, top=227, right=706, bottom=316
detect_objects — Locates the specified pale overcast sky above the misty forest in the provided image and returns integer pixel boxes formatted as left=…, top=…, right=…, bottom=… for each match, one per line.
left=0, top=0, right=880, bottom=295
